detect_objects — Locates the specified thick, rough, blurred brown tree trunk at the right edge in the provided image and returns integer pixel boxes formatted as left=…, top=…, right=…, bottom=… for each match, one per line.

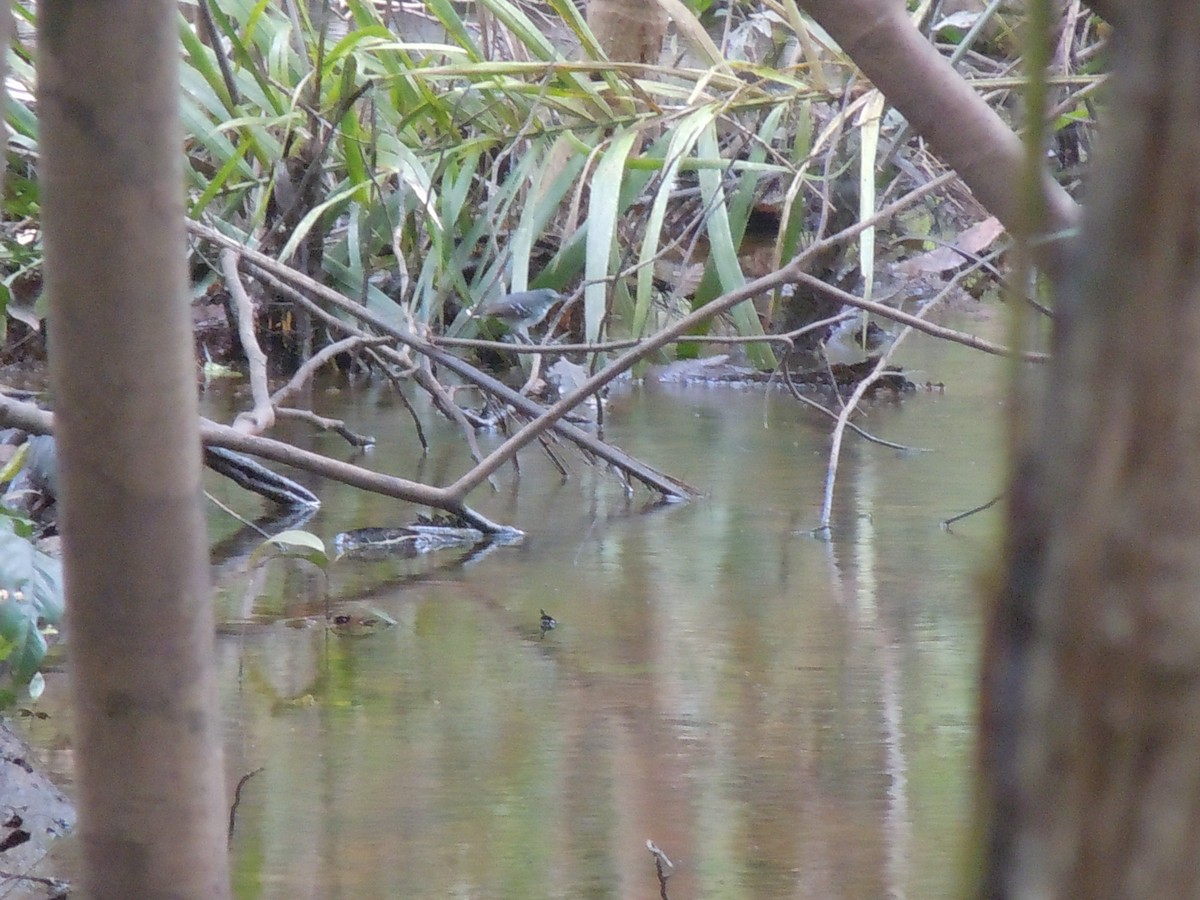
left=980, top=0, right=1200, bottom=898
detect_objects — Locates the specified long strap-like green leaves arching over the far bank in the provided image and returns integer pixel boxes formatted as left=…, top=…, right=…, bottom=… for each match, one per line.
left=5, top=0, right=835, bottom=361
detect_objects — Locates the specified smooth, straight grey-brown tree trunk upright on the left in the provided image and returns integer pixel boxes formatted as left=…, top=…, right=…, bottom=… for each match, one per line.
left=38, top=0, right=229, bottom=900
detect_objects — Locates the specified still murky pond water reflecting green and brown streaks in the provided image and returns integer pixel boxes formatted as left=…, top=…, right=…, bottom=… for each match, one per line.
left=34, top=321, right=1006, bottom=900
